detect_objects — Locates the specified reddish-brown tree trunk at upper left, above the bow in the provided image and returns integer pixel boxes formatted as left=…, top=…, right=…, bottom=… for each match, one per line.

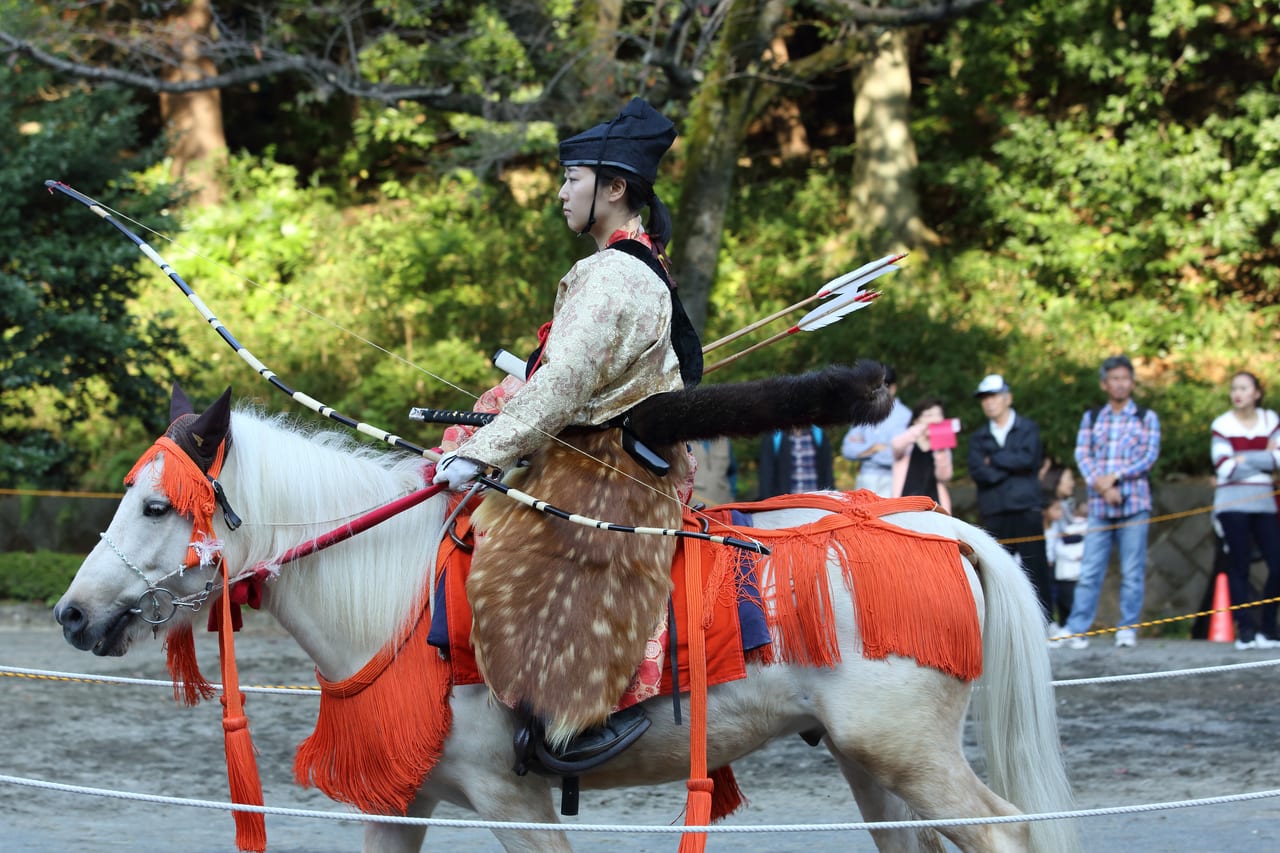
left=160, top=0, right=227, bottom=206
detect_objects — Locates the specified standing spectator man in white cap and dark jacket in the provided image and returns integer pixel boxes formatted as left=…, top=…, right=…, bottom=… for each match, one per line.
left=969, top=373, right=1056, bottom=617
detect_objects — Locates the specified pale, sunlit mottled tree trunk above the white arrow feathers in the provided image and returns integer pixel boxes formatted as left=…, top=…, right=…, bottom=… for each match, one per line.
left=849, top=29, right=937, bottom=252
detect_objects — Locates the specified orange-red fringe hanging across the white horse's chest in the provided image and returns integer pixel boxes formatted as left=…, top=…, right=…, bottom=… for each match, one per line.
left=293, top=601, right=453, bottom=815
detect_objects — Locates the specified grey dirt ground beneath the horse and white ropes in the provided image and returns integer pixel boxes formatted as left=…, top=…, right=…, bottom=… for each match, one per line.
left=0, top=607, right=1280, bottom=853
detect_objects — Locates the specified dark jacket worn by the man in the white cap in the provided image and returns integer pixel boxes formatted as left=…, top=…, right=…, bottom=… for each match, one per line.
left=969, top=412, right=1044, bottom=517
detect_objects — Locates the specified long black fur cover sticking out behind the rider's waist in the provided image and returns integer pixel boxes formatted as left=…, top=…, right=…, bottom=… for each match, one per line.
left=626, top=359, right=893, bottom=446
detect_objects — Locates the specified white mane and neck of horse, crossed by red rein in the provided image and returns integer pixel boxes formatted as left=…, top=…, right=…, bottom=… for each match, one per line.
left=215, top=407, right=445, bottom=649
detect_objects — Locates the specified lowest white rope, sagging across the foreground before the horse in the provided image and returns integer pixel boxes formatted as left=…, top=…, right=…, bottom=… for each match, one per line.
left=0, top=775, right=1280, bottom=835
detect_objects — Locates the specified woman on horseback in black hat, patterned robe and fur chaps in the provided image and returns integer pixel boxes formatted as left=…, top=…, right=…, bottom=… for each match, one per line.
left=434, top=99, right=703, bottom=768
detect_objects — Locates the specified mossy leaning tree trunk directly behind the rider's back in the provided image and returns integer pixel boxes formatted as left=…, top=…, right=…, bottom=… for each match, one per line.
left=672, top=0, right=787, bottom=333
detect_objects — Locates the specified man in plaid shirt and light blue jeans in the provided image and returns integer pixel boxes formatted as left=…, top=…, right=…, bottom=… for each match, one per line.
left=1051, top=355, right=1160, bottom=648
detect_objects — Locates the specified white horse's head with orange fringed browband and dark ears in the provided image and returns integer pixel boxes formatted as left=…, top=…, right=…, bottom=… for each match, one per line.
left=54, top=386, right=230, bottom=656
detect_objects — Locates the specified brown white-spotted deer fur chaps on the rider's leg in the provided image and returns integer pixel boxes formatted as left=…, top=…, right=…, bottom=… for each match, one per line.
left=467, top=429, right=689, bottom=748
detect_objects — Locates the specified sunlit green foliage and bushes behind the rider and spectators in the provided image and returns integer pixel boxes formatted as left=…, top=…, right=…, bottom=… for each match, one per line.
left=0, top=0, right=1280, bottom=489
